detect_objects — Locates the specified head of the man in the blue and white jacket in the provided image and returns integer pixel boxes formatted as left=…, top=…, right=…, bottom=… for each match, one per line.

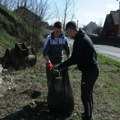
left=54, top=21, right=62, bottom=37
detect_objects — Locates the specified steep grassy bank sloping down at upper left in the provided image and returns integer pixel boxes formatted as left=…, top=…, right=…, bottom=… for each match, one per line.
left=0, top=5, right=44, bottom=54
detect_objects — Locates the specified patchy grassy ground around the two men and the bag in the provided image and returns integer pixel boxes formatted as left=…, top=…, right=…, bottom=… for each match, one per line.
left=0, top=56, right=120, bottom=120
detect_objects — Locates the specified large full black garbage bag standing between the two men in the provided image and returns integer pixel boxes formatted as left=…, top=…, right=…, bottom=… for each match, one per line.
left=47, top=68, right=74, bottom=115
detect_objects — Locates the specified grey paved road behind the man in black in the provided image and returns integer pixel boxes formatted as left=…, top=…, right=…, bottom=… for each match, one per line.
left=94, top=45, right=120, bottom=61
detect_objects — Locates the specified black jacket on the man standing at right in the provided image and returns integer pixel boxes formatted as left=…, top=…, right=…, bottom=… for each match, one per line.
left=58, top=30, right=97, bottom=71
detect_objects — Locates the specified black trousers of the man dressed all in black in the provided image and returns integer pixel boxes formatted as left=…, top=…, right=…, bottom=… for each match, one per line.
left=81, top=66, right=99, bottom=120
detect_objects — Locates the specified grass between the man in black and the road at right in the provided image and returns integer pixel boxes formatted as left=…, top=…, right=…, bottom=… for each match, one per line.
left=94, top=54, right=120, bottom=120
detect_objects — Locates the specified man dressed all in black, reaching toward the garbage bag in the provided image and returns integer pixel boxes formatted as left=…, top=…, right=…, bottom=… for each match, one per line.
left=57, top=21, right=99, bottom=120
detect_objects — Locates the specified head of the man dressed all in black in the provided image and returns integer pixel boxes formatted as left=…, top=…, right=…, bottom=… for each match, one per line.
left=66, top=21, right=77, bottom=39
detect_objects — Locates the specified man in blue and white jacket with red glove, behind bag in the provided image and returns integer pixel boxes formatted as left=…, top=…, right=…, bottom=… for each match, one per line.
left=43, top=21, right=70, bottom=88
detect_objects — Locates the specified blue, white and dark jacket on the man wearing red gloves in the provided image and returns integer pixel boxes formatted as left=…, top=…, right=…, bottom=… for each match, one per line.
left=43, top=33, right=70, bottom=64
